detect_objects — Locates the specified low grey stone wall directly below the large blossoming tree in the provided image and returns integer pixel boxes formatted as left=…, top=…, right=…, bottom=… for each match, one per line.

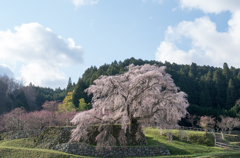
left=53, top=143, right=170, bottom=157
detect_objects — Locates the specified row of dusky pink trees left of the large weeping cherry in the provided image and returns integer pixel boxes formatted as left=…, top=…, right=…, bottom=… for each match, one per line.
left=0, top=105, right=76, bottom=132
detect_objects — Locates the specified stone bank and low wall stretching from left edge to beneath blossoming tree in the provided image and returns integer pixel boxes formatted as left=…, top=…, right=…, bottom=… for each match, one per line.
left=2, top=127, right=170, bottom=157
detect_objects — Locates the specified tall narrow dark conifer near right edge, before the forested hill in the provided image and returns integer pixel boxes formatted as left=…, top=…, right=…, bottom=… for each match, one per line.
left=225, top=79, right=237, bottom=109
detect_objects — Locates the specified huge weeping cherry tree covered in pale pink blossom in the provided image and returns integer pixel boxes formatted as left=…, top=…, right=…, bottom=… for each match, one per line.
left=70, top=64, right=189, bottom=147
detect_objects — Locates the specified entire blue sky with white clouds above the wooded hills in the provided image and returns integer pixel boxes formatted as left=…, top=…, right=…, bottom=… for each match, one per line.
left=0, top=0, right=240, bottom=89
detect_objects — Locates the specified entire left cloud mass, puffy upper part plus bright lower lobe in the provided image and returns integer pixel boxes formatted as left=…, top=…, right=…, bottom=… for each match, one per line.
left=0, top=23, right=83, bottom=87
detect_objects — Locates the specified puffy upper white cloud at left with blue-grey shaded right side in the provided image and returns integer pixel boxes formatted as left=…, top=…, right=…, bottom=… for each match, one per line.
left=0, top=23, right=83, bottom=65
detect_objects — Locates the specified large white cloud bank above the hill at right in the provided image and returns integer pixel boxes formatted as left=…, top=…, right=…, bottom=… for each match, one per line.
left=156, top=0, right=240, bottom=67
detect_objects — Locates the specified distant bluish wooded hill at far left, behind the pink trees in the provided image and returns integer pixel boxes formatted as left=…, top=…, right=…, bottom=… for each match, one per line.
left=0, top=76, right=75, bottom=114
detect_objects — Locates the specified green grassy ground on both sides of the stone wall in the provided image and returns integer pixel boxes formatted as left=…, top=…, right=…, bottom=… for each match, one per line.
left=0, top=127, right=240, bottom=158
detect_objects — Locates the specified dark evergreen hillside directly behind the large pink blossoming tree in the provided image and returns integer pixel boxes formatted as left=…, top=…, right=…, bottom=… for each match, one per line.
left=73, top=58, right=240, bottom=117
